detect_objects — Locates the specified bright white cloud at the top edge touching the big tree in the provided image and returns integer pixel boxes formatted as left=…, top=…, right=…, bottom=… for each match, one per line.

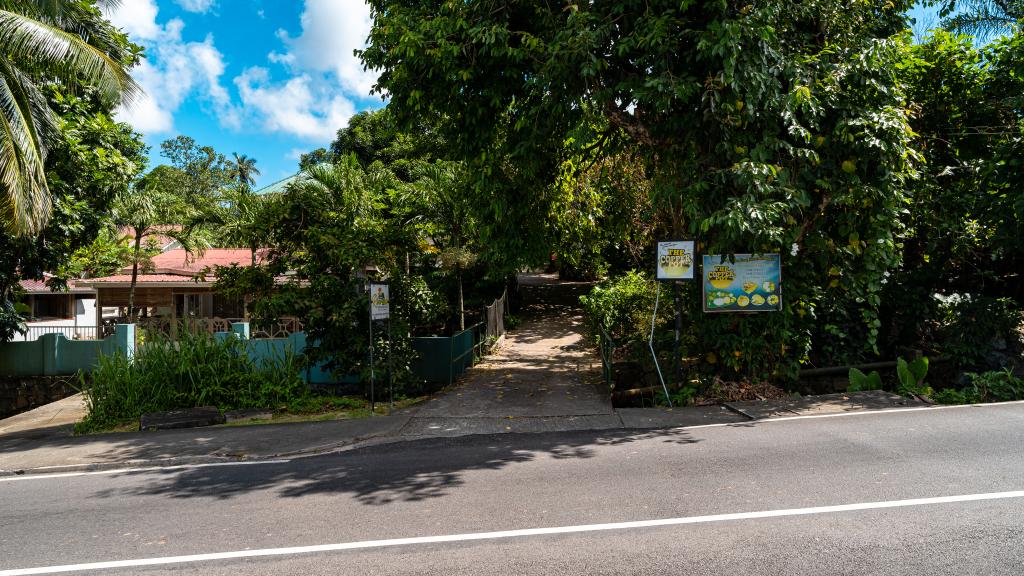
left=273, top=0, right=378, bottom=97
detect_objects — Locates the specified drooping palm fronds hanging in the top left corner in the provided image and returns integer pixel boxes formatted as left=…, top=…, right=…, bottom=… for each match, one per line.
left=0, top=0, right=139, bottom=236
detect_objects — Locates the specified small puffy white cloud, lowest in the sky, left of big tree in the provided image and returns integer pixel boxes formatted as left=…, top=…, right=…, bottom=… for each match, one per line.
left=234, top=67, right=355, bottom=140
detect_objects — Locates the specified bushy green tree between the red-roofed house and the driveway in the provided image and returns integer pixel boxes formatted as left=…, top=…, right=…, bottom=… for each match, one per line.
left=217, top=159, right=390, bottom=375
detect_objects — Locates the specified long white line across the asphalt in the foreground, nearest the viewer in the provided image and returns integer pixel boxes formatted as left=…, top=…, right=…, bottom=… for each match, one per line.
left=0, top=490, right=1024, bottom=576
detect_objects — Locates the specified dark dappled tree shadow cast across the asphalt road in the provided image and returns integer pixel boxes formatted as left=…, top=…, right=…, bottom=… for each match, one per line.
left=97, top=429, right=697, bottom=506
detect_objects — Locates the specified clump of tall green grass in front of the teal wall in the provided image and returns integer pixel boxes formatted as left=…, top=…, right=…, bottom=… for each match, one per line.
left=76, top=330, right=310, bottom=433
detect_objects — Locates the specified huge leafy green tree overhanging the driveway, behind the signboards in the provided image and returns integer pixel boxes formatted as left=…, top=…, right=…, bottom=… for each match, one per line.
left=361, top=0, right=919, bottom=378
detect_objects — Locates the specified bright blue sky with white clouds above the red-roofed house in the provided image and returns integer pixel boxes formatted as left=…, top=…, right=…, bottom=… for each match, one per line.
left=101, top=0, right=384, bottom=188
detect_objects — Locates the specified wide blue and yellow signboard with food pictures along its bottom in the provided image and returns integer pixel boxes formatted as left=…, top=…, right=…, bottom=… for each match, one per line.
left=703, top=254, right=782, bottom=312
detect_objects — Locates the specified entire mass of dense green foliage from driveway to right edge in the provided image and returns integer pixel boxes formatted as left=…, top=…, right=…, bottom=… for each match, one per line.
left=361, top=0, right=1024, bottom=387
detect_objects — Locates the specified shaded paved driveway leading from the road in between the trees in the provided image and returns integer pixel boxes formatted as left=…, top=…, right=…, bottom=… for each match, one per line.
left=402, top=275, right=622, bottom=436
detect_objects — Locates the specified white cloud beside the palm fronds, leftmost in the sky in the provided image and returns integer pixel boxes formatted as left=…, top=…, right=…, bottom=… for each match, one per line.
left=108, top=0, right=242, bottom=134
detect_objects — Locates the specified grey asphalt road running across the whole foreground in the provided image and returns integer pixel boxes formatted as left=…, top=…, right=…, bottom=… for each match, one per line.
left=0, top=404, right=1024, bottom=575
